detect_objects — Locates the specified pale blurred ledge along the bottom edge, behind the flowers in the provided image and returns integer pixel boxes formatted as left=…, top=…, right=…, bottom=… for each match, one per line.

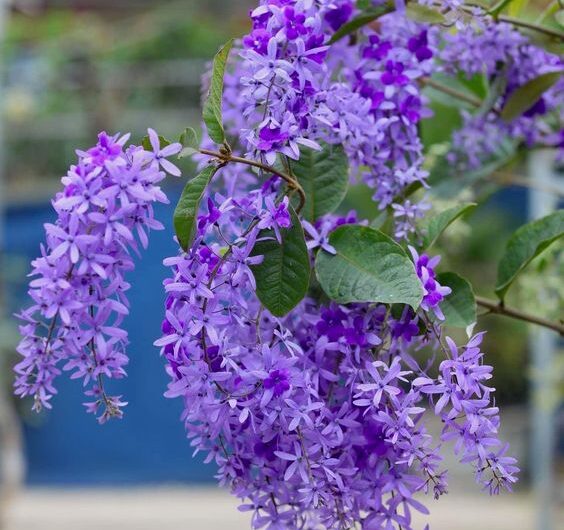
left=5, top=488, right=552, bottom=530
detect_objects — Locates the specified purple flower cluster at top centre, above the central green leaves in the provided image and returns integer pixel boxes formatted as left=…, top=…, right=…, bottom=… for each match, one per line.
left=218, top=0, right=434, bottom=237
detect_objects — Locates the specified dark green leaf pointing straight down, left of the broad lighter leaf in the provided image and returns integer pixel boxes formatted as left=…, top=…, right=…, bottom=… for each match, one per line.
left=252, top=207, right=311, bottom=317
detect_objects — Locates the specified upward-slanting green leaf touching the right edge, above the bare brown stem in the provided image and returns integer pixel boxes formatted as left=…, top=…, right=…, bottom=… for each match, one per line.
left=495, top=210, right=564, bottom=300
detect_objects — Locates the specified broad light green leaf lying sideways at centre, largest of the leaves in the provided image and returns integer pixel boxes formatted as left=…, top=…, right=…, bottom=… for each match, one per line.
left=315, top=225, right=423, bottom=309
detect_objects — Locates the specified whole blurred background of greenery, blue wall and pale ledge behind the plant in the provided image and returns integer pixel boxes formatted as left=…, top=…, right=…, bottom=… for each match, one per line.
left=0, top=0, right=564, bottom=530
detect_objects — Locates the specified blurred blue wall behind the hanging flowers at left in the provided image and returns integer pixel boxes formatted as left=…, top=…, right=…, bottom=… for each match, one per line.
left=5, top=192, right=214, bottom=485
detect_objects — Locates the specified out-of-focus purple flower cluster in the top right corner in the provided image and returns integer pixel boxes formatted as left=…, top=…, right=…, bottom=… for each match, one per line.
left=440, top=23, right=564, bottom=168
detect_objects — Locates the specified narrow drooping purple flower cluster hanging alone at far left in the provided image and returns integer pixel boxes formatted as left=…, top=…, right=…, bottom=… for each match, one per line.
left=15, top=130, right=181, bottom=421
